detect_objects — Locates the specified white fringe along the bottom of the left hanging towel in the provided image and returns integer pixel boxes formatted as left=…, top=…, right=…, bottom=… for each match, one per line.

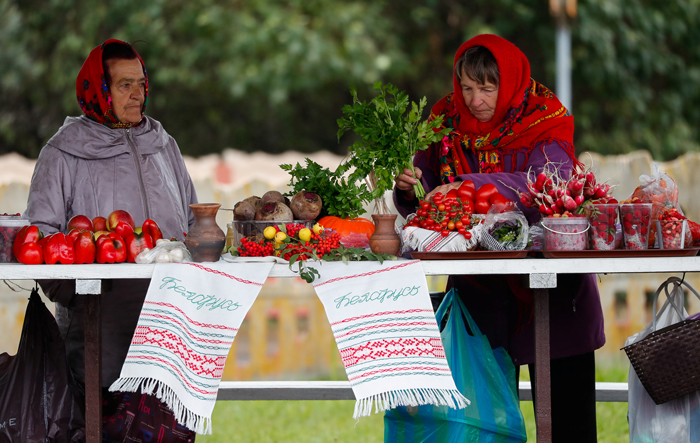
left=109, top=377, right=212, bottom=435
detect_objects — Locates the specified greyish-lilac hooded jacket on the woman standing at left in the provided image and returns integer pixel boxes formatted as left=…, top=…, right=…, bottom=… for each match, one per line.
left=24, top=116, right=197, bottom=386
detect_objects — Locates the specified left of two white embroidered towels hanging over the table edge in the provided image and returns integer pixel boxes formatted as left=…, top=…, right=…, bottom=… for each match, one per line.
left=109, top=261, right=274, bottom=434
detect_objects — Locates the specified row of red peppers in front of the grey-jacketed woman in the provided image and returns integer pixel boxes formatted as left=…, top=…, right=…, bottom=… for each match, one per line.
left=12, top=219, right=163, bottom=265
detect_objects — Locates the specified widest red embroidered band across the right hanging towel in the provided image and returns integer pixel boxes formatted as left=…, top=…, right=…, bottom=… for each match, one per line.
left=340, top=338, right=445, bottom=368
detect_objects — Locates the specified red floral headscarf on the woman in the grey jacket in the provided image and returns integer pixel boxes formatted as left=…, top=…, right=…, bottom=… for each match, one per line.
left=75, top=39, right=148, bottom=129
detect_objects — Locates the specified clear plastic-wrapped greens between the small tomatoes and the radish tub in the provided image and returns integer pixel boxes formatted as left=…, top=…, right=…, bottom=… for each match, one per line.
left=479, top=210, right=530, bottom=251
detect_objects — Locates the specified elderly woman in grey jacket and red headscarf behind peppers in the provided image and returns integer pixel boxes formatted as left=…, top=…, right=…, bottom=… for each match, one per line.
left=25, top=40, right=197, bottom=418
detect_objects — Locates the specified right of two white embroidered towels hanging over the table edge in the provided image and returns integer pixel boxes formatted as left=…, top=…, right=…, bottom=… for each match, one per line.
left=314, top=260, right=469, bottom=418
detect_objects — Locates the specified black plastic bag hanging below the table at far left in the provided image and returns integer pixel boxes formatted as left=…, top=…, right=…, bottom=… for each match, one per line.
left=0, top=289, right=85, bottom=443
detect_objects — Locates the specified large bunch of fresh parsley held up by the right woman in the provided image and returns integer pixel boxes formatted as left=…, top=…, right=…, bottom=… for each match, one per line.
left=338, top=82, right=449, bottom=206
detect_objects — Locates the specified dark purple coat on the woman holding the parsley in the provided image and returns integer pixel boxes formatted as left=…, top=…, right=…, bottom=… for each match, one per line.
left=394, top=143, right=605, bottom=365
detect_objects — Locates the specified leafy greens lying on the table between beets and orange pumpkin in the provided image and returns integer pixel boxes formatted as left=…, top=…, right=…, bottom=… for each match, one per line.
left=280, top=158, right=372, bottom=218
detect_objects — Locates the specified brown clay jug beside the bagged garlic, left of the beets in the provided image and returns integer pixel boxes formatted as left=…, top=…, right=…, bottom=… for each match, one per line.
left=185, top=203, right=226, bottom=263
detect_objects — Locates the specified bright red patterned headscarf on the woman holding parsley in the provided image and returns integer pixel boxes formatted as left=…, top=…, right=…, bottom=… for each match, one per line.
left=427, top=34, right=576, bottom=183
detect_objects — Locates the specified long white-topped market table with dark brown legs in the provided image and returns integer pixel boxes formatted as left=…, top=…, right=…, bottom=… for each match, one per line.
left=0, top=257, right=700, bottom=443
